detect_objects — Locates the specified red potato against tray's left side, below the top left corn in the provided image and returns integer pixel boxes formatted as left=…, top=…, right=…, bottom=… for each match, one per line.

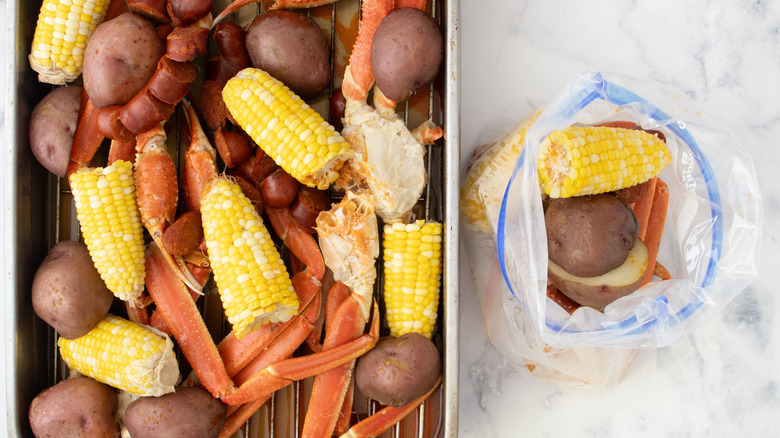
left=29, top=85, right=82, bottom=178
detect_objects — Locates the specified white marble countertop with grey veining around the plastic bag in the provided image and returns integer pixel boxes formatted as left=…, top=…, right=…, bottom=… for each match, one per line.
left=0, top=0, right=780, bottom=437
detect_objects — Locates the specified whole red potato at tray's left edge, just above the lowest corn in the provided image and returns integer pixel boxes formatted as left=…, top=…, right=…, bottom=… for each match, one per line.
left=32, top=241, right=114, bottom=339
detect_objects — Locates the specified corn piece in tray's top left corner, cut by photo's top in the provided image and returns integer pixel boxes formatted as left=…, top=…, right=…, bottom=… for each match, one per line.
left=29, top=0, right=110, bottom=85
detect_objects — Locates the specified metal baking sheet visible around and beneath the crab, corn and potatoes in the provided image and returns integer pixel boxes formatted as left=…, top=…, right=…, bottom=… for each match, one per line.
left=0, top=0, right=460, bottom=437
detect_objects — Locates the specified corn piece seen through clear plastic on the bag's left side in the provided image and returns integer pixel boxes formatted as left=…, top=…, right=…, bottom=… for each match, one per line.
left=460, top=108, right=542, bottom=234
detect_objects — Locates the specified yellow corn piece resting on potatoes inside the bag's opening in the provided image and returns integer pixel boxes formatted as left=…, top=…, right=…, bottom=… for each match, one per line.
left=538, top=126, right=671, bottom=198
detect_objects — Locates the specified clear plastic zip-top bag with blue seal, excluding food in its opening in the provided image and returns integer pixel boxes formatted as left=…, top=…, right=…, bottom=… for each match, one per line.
left=461, top=73, right=762, bottom=386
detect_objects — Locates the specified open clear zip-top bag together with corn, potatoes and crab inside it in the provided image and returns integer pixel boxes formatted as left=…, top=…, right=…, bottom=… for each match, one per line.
left=461, top=73, right=762, bottom=387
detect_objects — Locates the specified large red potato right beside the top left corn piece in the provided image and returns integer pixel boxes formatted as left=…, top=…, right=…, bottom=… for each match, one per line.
left=82, top=13, right=165, bottom=108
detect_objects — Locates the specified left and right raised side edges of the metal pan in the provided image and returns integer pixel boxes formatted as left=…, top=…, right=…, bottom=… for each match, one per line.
left=0, top=0, right=460, bottom=437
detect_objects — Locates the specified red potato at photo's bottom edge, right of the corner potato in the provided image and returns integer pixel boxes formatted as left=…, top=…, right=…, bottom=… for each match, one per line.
left=125, top=387, right=227, bottom=438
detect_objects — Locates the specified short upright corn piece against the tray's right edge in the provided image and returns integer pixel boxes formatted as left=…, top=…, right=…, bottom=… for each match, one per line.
left=382, top=220, right=442, bottom=339
